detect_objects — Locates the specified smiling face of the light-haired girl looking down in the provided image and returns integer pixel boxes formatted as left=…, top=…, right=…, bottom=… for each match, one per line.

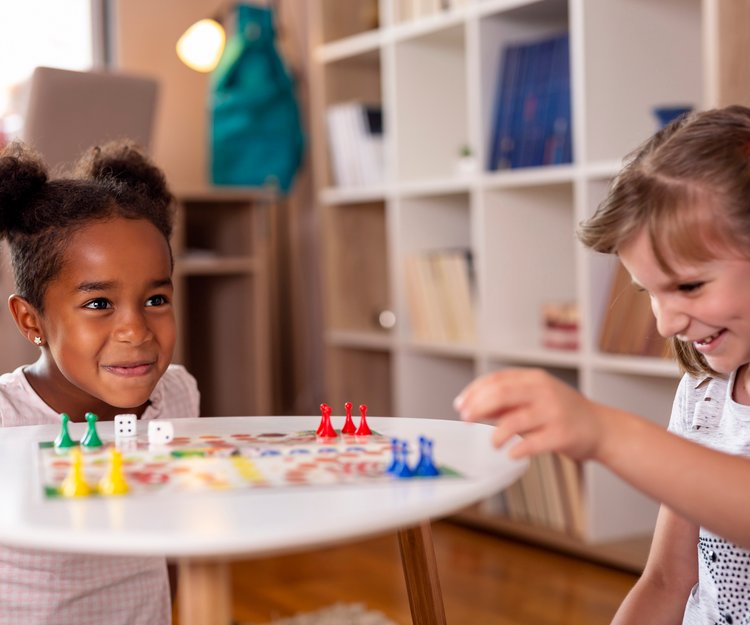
left=619, top=229, right=750, bottom=374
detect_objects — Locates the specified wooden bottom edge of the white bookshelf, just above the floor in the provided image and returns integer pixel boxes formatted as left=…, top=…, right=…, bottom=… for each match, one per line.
left=449, top=505, right=651, bottom=574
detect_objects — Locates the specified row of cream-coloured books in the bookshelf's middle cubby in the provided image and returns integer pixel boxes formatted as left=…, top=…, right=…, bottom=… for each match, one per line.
left=405, top=250, right=476, bottom=343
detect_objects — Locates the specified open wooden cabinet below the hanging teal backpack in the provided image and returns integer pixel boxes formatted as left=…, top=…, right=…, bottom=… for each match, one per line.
left=173, top=189, right=275, bottom=416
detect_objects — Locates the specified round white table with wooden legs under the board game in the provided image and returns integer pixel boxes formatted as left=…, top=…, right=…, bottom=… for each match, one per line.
left=0, top=416, right=527, bottom=625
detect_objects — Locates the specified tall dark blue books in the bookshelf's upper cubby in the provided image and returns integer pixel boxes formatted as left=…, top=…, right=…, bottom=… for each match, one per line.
left=488, top=33, right=573, bottom=171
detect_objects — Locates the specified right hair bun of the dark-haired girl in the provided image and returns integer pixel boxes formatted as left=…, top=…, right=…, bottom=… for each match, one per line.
left=73, top=140, right=172, bottom=206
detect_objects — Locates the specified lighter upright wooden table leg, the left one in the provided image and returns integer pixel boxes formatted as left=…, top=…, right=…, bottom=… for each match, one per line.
left=177, top=560, right=232, bottom=625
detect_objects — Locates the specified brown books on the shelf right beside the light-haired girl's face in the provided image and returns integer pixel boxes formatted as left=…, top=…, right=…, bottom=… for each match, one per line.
left=599, top=263, right=667, bottom=357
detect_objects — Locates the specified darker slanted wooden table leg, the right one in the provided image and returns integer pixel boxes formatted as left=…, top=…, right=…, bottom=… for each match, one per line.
left=398, top=521, right=446, bottom=625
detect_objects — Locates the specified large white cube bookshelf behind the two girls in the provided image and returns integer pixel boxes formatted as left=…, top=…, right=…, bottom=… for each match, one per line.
left=310, top=0, right=738, bottom=568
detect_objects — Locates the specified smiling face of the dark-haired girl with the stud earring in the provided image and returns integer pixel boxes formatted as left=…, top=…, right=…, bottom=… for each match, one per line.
left=31, top=218, right=176, bottom=418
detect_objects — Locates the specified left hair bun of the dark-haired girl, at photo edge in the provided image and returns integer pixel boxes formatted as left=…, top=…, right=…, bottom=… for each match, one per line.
left=0, top=142, right=49, bottom=238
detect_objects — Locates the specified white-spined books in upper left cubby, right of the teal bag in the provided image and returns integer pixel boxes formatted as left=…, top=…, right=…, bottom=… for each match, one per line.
left=326, top=102, right=385, bottom=187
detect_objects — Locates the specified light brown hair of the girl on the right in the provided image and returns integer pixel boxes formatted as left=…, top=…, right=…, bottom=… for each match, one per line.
left=578, top=106, right=750, bottom=375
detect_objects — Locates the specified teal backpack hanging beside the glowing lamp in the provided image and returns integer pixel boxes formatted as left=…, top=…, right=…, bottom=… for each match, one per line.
left=211, top=4, right=305, bottom=193
